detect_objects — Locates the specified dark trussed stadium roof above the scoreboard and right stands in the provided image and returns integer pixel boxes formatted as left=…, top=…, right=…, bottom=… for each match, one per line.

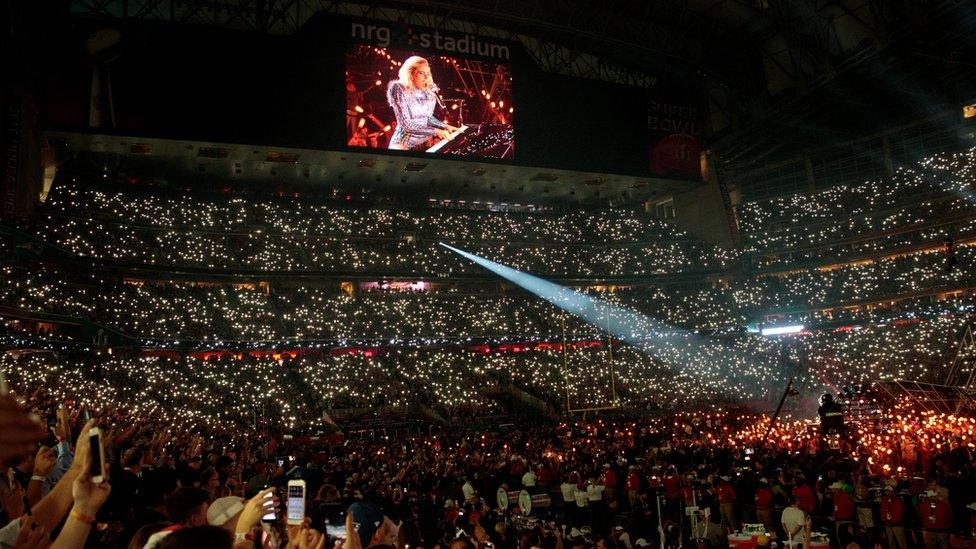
left=59, top=0, right=976, bottom=165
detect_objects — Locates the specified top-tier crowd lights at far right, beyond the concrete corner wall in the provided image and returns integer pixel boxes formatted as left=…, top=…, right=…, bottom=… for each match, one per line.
left=739, top=149, right=976, bottom=267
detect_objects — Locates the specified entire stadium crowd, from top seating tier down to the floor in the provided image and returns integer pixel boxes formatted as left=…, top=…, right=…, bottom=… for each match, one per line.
left=0, top=142, right=976, bottom=549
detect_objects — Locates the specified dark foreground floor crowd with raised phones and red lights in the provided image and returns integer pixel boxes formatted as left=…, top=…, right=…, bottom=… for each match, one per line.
left=0, top=377, right=976, bottom=549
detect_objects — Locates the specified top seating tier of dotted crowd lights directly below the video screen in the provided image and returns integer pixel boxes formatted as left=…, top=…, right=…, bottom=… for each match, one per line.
left=40, top=181, right=736, bottom=276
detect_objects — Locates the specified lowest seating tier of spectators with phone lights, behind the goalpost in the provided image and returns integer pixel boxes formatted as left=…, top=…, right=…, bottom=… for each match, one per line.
left=0, top=296, right=971, bottom=430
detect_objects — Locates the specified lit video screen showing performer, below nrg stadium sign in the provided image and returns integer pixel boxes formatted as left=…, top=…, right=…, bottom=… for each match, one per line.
left=346, top=45, right=515, bottom=159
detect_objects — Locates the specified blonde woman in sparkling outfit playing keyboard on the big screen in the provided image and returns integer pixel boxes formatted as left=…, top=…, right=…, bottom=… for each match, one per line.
left=386, top=55, right=458, bottom=150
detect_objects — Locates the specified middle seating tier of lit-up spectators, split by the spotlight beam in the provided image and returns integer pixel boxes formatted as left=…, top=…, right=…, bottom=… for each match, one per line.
left=0, top=253, right=976, bottom=342
